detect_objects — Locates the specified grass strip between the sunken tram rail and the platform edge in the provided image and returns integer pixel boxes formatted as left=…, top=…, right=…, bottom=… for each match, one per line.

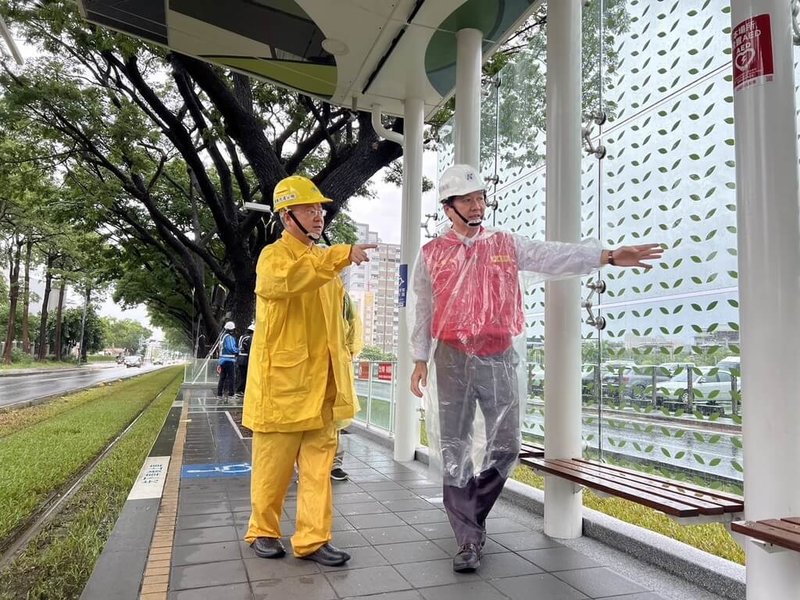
left=0, top=370, right=182, bottom=600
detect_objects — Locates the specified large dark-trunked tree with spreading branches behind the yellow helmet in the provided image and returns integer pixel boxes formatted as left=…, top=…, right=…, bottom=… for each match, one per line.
left=0, top=0, right=402, bottom=354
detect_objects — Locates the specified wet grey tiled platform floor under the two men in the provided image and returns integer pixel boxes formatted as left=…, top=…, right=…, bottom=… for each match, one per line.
left=169, top=390, right=692, bottom=600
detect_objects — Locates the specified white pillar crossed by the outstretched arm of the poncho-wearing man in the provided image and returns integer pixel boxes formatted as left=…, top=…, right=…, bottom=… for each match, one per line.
left=544, top=0, right=583, bottom=538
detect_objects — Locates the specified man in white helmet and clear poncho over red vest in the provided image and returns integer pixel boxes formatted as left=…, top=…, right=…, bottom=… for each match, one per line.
left=411, top=165, right=661, bottom=572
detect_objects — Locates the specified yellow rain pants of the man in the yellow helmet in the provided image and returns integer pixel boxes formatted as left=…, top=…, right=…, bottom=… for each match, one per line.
left=244, top=371, right=336, bottom=557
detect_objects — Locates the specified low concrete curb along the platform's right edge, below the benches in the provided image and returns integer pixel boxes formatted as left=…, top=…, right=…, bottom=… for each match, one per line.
left=351, top=422, right=746, bottom=600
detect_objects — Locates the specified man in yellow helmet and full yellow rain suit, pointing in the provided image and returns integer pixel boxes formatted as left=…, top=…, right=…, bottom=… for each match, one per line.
left=242, top=176, right=375, bottom=566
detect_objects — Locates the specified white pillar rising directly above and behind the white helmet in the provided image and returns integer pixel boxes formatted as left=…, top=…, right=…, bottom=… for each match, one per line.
left=455, top=29, right=483, bottom=169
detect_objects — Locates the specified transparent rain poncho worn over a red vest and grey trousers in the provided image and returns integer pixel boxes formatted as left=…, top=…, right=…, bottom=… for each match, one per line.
left=410, top=228, right=601, bottom=487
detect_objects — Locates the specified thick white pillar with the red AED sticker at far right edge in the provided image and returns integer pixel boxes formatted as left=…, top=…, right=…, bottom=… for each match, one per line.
left=731, top=0, right=800, bottom=600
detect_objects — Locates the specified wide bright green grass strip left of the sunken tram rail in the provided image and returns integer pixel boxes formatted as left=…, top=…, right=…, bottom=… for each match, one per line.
left=0, top=368, right=180, bottom=540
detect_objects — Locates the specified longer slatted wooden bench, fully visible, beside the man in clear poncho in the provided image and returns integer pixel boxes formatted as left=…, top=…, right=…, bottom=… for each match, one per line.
left=520, top=457, right=744, bottom=524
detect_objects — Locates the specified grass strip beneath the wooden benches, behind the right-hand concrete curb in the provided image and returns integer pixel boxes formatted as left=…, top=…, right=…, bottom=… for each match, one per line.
left=512, top=465, right=744, bottom=565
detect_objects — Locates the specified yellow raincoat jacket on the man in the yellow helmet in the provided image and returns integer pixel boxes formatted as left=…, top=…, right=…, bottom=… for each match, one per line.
left=242, top=232, right=356, bottom=433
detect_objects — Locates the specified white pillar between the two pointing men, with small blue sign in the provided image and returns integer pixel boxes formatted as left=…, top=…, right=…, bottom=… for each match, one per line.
left=394, top=98, right=425, bottom=461
